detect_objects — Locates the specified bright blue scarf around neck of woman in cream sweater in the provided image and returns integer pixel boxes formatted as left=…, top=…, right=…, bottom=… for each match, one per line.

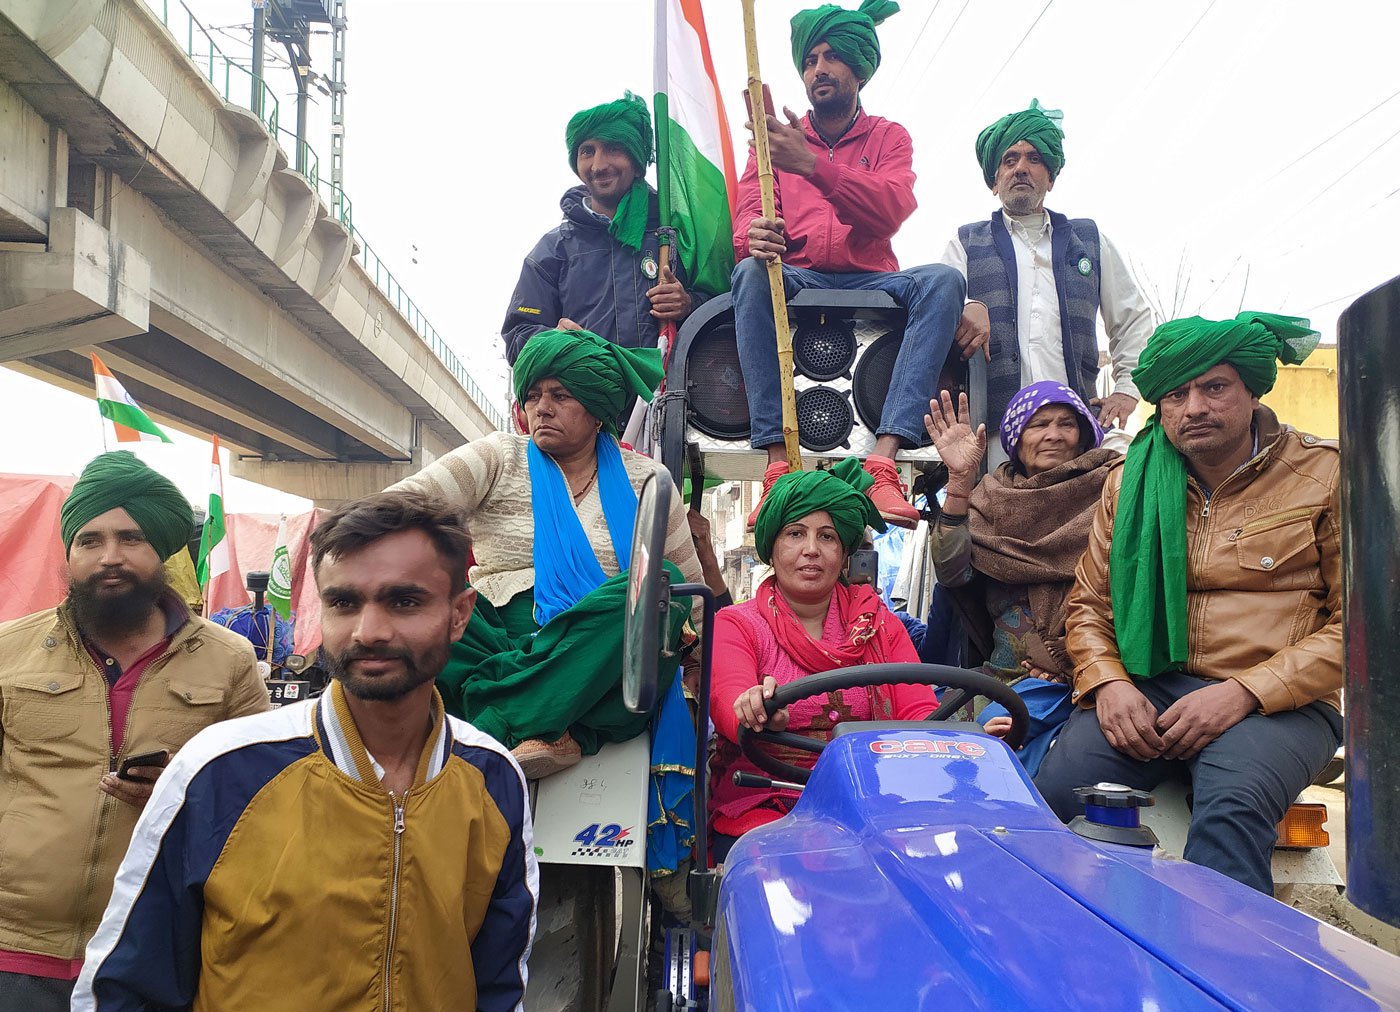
left=529, top=433, right=637, bottom=626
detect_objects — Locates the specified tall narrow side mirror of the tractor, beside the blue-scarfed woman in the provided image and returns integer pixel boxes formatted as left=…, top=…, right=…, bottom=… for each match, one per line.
left=622, top=473, right=675, bottom=714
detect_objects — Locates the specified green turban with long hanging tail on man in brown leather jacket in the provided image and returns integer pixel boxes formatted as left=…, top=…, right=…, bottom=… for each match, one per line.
left=1109, top=312, right=1319, bottom=677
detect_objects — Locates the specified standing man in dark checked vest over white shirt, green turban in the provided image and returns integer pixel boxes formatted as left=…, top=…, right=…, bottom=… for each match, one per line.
left=942, top=99, right=1152, bottom=463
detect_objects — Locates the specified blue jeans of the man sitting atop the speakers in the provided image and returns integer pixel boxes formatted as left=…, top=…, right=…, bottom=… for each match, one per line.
left=731, top=256, right=967, bottom=449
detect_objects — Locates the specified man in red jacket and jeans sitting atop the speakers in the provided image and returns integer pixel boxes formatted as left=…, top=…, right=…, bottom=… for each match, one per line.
left=732, top=0, right=987, bottom=528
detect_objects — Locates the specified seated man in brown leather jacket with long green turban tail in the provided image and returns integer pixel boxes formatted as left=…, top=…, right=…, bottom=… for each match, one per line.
left=1036, top=314, right=1343, bottom=892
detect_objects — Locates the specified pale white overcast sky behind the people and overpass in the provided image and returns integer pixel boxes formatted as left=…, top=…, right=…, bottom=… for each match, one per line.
left=0, top=0, right=1400, bottom=511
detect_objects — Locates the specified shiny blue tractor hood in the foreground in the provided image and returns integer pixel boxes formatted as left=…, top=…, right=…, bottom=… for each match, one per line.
left=711, top=726, right=1400, bottom=1012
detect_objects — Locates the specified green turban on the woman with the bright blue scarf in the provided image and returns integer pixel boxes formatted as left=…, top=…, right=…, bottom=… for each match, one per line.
left=515, top=330, right=665, bottom=435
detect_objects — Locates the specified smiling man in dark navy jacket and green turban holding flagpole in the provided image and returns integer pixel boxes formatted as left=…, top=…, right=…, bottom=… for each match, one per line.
left=501, top=92, right=694, bottom=365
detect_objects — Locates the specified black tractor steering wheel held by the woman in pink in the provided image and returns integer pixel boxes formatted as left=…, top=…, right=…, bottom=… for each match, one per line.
left=739, top=663, right=1030, bottom=784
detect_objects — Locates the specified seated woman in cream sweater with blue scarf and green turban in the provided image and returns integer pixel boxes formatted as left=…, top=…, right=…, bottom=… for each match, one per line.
left=399, top=330, right=703, bottom=777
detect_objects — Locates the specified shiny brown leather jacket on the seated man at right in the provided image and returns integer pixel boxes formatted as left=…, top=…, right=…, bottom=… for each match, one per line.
left=1065, top=406, right=1343, bottom=714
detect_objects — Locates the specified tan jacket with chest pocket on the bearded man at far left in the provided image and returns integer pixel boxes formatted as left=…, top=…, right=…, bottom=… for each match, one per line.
left=0, top=602, right=272, bottom=959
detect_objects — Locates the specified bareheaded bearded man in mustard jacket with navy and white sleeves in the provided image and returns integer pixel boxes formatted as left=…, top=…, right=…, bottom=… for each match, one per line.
left=73, top=491, right=539, bottom=1012
